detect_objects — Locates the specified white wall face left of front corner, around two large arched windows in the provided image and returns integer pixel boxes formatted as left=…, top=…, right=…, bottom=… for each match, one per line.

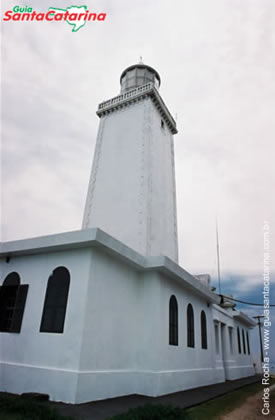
left=0, top=249, right=90, bottom=402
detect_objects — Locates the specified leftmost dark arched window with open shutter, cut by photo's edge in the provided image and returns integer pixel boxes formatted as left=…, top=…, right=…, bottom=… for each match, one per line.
left=0, top=271, right=29, bottom=333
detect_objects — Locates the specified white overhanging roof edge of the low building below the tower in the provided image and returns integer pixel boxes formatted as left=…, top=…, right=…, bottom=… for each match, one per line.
left=0, top=228, right=220, bottom=303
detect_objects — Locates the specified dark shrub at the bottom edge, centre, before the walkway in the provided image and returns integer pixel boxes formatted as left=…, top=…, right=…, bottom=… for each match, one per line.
left=106, top=404, right=190, bottom=420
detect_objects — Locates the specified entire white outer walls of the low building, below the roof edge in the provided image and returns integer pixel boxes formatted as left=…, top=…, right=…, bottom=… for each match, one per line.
left=0, top=245, right=254, bottom=403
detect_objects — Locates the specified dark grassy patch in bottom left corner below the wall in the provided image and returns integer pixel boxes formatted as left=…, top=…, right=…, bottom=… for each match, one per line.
left=0, top=396, right=74, bottom=420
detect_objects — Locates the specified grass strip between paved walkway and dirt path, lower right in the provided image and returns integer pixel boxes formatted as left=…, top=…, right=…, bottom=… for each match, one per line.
left=187, top=378, right=275, bottom=420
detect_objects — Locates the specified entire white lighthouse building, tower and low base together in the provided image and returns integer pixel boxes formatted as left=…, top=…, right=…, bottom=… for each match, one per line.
left=0, top=63, right=255, bottom=403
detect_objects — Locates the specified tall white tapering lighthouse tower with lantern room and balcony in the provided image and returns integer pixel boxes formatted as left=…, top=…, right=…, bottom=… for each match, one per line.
left=82, top=63, right=178, bottom=262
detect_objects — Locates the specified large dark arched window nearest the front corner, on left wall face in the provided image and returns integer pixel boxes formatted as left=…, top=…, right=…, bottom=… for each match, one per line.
left=40, top=267, right=70, bottom=333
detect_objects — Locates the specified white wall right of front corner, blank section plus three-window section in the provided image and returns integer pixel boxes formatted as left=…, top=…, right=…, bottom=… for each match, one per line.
left=76, top=258, right=224, bottom=402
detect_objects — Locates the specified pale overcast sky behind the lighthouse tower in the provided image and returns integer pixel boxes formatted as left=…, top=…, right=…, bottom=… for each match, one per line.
left=1, top=0, right=275, bottom=354
